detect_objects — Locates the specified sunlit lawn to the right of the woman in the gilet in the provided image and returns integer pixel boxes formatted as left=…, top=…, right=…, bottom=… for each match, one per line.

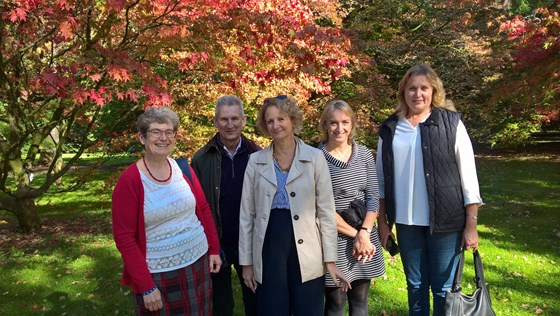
left=471, top=157, right=560, bottom=315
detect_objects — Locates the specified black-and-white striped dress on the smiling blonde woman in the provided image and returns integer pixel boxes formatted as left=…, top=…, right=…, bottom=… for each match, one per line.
left=319, top=143, right=385, bottom=287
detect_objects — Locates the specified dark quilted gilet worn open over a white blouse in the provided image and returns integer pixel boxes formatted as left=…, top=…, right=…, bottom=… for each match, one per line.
left=379, top=108, right=465, bottom=232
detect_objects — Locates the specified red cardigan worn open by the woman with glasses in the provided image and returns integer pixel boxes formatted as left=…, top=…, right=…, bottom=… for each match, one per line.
left=111, top=163, right=220, bottom=293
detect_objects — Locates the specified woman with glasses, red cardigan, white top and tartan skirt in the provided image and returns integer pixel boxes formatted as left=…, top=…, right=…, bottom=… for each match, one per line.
left=112, top=107, right=221, bottom=315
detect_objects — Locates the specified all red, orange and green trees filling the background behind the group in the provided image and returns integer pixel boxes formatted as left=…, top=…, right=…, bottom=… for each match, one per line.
left=0, top=0, right=560, bottom=227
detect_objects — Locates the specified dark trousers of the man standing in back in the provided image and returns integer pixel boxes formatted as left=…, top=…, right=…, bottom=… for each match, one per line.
left=212, top=248, right=257, bottom=316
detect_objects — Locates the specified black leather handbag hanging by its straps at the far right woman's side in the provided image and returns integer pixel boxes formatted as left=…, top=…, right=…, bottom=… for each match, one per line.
left=444, top=250, right=496, bottom=316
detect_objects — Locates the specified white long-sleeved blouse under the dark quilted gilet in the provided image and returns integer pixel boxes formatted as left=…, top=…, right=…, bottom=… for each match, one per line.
left=377, top=113, right=482, bottom=226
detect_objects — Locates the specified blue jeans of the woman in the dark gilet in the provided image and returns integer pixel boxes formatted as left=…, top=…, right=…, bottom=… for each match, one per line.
left=396, top=224, right=463, bottom=316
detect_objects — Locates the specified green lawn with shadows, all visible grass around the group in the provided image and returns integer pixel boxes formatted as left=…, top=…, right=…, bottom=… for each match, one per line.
left=0, top=156, right=560, bottom=315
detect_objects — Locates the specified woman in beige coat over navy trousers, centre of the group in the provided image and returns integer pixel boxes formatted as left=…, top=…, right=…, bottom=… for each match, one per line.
left=239, top=96, right=350, bottom=316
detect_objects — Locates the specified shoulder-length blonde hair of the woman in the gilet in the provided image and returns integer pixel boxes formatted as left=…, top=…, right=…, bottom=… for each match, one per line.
left=395, top=64, right=456, bottom=118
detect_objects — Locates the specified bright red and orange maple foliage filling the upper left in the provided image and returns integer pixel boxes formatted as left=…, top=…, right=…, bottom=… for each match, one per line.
left=0, top=0, right=351, bottom=229
